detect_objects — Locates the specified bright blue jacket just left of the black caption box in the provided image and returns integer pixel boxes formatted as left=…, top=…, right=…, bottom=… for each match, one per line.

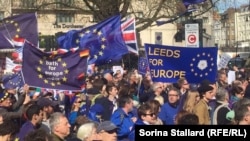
left=111, top=108, right=134, bottom=141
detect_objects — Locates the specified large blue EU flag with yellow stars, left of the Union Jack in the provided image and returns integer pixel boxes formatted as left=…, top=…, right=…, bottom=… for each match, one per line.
left=57, top=15, right=128, bottom=65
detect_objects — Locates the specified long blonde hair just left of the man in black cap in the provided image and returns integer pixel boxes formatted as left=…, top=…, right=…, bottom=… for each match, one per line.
left=183, top=90, right=199, bottom=113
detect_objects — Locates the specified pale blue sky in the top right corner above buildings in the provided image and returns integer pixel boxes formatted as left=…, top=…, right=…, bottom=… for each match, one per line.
left=214, top=0, right=250, bottom=12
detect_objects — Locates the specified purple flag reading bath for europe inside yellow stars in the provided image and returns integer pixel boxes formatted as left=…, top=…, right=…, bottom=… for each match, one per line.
left=22, top=42, right=88, bottom=91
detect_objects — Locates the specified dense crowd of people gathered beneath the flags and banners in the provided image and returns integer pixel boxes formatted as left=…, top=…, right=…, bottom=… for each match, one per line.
left=0, top=67, right=250, bottom=141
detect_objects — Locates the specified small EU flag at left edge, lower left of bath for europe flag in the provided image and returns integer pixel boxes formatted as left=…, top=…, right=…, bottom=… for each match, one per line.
left=2, top=71, right=24, bottom=89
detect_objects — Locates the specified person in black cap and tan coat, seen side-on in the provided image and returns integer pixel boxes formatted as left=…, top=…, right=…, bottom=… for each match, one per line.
left=194, top=85, right=214, bottom=125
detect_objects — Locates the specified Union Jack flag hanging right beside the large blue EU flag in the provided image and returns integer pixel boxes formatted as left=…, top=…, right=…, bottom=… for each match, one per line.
left=121, top=18, right=139, bottom=55
